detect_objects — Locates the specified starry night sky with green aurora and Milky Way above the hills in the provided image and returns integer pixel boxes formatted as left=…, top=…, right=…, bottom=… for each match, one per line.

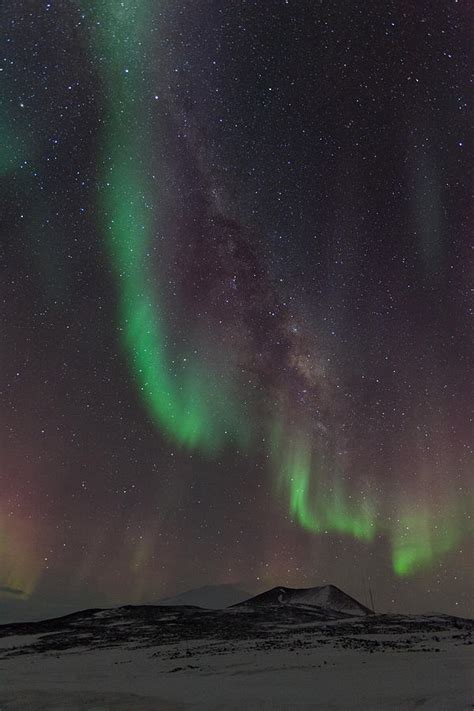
left=0, top=0, right=473, bottom=620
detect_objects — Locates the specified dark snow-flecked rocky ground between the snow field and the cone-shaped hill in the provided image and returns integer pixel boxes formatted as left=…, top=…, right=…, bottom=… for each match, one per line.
left=0, top=604, right=474, bottom=658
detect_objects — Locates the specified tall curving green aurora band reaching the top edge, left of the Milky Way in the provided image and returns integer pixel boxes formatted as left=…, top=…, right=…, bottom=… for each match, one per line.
left=91, top=0, right=249, bottom=454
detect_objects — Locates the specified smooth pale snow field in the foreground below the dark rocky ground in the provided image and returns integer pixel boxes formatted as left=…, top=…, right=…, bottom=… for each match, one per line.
left=0, top=647, right=473, bottom=711
